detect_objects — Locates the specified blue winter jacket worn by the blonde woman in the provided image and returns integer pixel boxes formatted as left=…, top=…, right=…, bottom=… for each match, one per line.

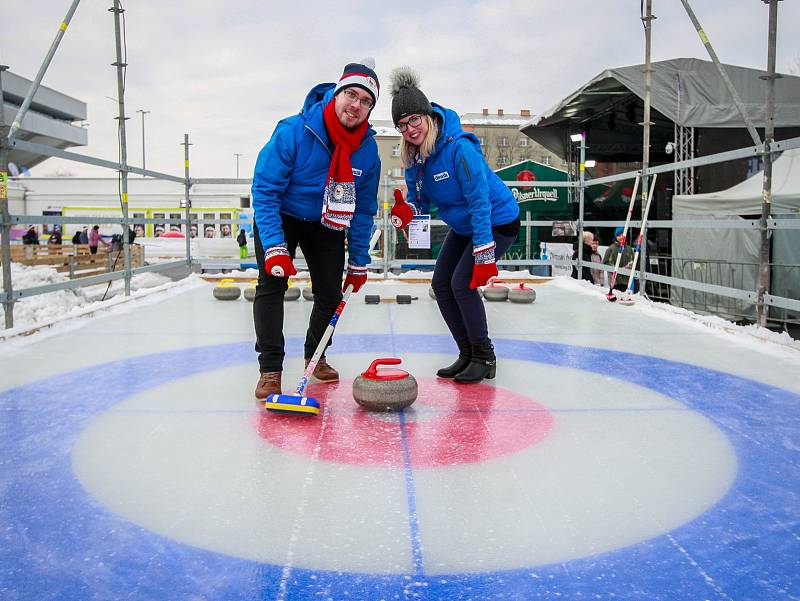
left=405, top=102, right=519, bottom=246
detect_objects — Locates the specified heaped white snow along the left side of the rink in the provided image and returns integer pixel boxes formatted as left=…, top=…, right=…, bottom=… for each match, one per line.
left=0, top=263, right=203, bottom=343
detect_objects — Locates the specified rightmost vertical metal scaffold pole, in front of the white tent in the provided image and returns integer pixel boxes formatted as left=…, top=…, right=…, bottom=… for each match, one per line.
left=756, top=0, right=780, bottom=328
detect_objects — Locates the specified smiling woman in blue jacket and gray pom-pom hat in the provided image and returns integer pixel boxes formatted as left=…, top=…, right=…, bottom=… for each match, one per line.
left=392, top=67, right=519, bottom=383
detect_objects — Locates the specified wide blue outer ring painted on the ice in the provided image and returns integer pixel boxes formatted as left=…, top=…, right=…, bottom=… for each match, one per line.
left=0, top=335, right=800, bottom=601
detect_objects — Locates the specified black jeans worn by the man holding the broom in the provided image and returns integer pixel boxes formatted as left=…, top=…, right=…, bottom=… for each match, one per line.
left=253, top=215, right=345, bottom=371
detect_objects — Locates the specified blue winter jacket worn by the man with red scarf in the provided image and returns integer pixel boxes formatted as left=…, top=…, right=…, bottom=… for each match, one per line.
left=252, top=83, right=381, bottom=266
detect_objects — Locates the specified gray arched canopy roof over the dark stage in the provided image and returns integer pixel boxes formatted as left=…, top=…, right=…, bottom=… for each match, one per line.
left=520, top=58, right=800, bottom=184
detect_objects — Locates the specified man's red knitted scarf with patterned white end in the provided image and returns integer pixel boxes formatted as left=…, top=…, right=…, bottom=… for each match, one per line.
left=322, top=98, right=369, bottom=230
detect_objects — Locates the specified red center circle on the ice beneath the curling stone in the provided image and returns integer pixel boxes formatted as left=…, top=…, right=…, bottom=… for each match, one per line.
left=255, top=378, right=554, bottom=467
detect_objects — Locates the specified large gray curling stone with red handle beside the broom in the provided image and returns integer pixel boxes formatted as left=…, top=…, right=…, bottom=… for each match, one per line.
left=353, top=357, right=417, bottom=411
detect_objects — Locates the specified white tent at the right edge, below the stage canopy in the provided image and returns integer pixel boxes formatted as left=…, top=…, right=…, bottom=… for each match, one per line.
left=671, top=149, right=800, bottom=319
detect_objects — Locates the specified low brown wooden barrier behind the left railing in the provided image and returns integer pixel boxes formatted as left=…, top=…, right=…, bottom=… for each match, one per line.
left=11, top=244, right=144, bottom=279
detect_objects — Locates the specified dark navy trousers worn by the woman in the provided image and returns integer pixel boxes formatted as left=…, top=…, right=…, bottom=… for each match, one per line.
left=431, top=220, right=519, bottom=344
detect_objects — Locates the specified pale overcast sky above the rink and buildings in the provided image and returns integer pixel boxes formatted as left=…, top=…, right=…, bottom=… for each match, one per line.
left=0, top=0, right=800, bottom=177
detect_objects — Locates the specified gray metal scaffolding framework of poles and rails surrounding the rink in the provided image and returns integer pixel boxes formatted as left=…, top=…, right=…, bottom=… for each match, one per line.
left=0, top=0, right=800, bottom=328
